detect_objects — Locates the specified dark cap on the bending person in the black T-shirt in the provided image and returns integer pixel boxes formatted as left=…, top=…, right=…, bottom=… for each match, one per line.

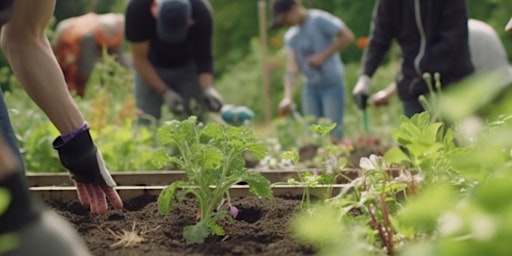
left=156, top=0, right=192, bottom=42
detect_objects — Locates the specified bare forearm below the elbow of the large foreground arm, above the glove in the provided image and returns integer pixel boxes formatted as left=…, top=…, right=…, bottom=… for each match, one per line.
left=2, top=26, right=85, bottom=134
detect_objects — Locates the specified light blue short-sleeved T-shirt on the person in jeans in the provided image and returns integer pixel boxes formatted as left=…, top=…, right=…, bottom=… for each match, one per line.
left=285, top=9, right=345, bottom=85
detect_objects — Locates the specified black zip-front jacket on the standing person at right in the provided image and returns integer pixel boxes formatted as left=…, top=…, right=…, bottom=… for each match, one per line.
left=362, top=0, right=473, bottom=101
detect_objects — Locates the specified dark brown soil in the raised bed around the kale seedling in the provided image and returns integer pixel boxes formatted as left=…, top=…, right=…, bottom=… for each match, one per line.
left=47, top=195, right=315, bottom=256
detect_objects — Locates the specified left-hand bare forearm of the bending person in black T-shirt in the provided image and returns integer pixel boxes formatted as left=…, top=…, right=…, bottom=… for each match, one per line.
left=131, top=41, right=168, bottom=95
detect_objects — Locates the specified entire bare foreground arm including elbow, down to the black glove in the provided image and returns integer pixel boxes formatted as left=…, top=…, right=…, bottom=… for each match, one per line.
left=1, top=0, right=85, bottom=134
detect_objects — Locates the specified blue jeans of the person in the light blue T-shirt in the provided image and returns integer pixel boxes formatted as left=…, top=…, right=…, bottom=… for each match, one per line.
left=302, top=78, right=345, bottom=139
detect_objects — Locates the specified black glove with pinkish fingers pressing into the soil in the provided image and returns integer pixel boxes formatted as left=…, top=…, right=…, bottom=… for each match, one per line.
left=53, top=126, right=123, bottom=214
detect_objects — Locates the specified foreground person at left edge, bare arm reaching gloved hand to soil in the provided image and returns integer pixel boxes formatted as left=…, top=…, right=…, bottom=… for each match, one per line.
left=0, top=0, right=123, bottom=256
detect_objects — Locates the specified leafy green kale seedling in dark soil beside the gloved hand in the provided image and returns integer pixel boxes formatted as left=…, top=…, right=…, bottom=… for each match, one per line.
left=152, top=117, right=273, bottom=243
